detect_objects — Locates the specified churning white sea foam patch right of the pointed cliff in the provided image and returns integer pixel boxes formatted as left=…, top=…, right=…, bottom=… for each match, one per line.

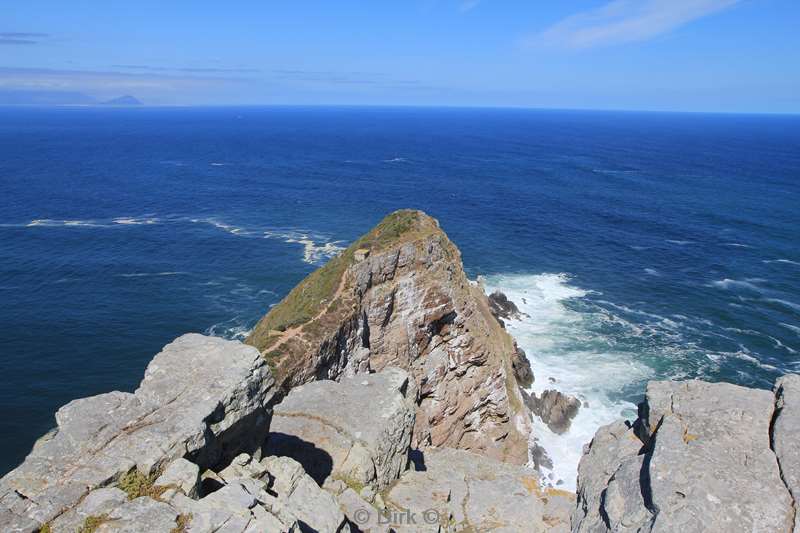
left=484, top=274, right=648, bottom=490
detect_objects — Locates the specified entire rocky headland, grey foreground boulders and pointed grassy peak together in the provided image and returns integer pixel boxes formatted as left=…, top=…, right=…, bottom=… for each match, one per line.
left=0, top=210, right=800, bottom=533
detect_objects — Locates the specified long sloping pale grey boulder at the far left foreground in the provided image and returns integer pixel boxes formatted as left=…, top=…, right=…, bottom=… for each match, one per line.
left=0, top=334, right=274, bottom=528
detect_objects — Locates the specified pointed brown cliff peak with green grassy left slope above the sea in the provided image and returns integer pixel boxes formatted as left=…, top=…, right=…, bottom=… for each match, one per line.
left=246, top=210, right=530, bottom=463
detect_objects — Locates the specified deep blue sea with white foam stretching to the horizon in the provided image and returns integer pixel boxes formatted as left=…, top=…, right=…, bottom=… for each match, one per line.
left=0, top=107, right=800, bottom=486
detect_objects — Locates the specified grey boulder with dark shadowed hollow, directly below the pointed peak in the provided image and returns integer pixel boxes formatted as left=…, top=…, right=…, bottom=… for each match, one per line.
left=267, top=368, right=417, bottom=491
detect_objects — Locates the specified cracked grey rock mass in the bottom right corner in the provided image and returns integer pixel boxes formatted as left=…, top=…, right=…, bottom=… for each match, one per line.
left=572, top=376, right=800, bottom=533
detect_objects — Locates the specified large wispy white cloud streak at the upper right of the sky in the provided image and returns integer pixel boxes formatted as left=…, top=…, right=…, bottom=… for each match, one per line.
left=530, top=0, right=740, bottom=48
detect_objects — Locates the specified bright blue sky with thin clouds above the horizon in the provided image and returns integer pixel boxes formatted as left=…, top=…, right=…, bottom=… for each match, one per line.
left=0, top=0, right=800, bottom=113
